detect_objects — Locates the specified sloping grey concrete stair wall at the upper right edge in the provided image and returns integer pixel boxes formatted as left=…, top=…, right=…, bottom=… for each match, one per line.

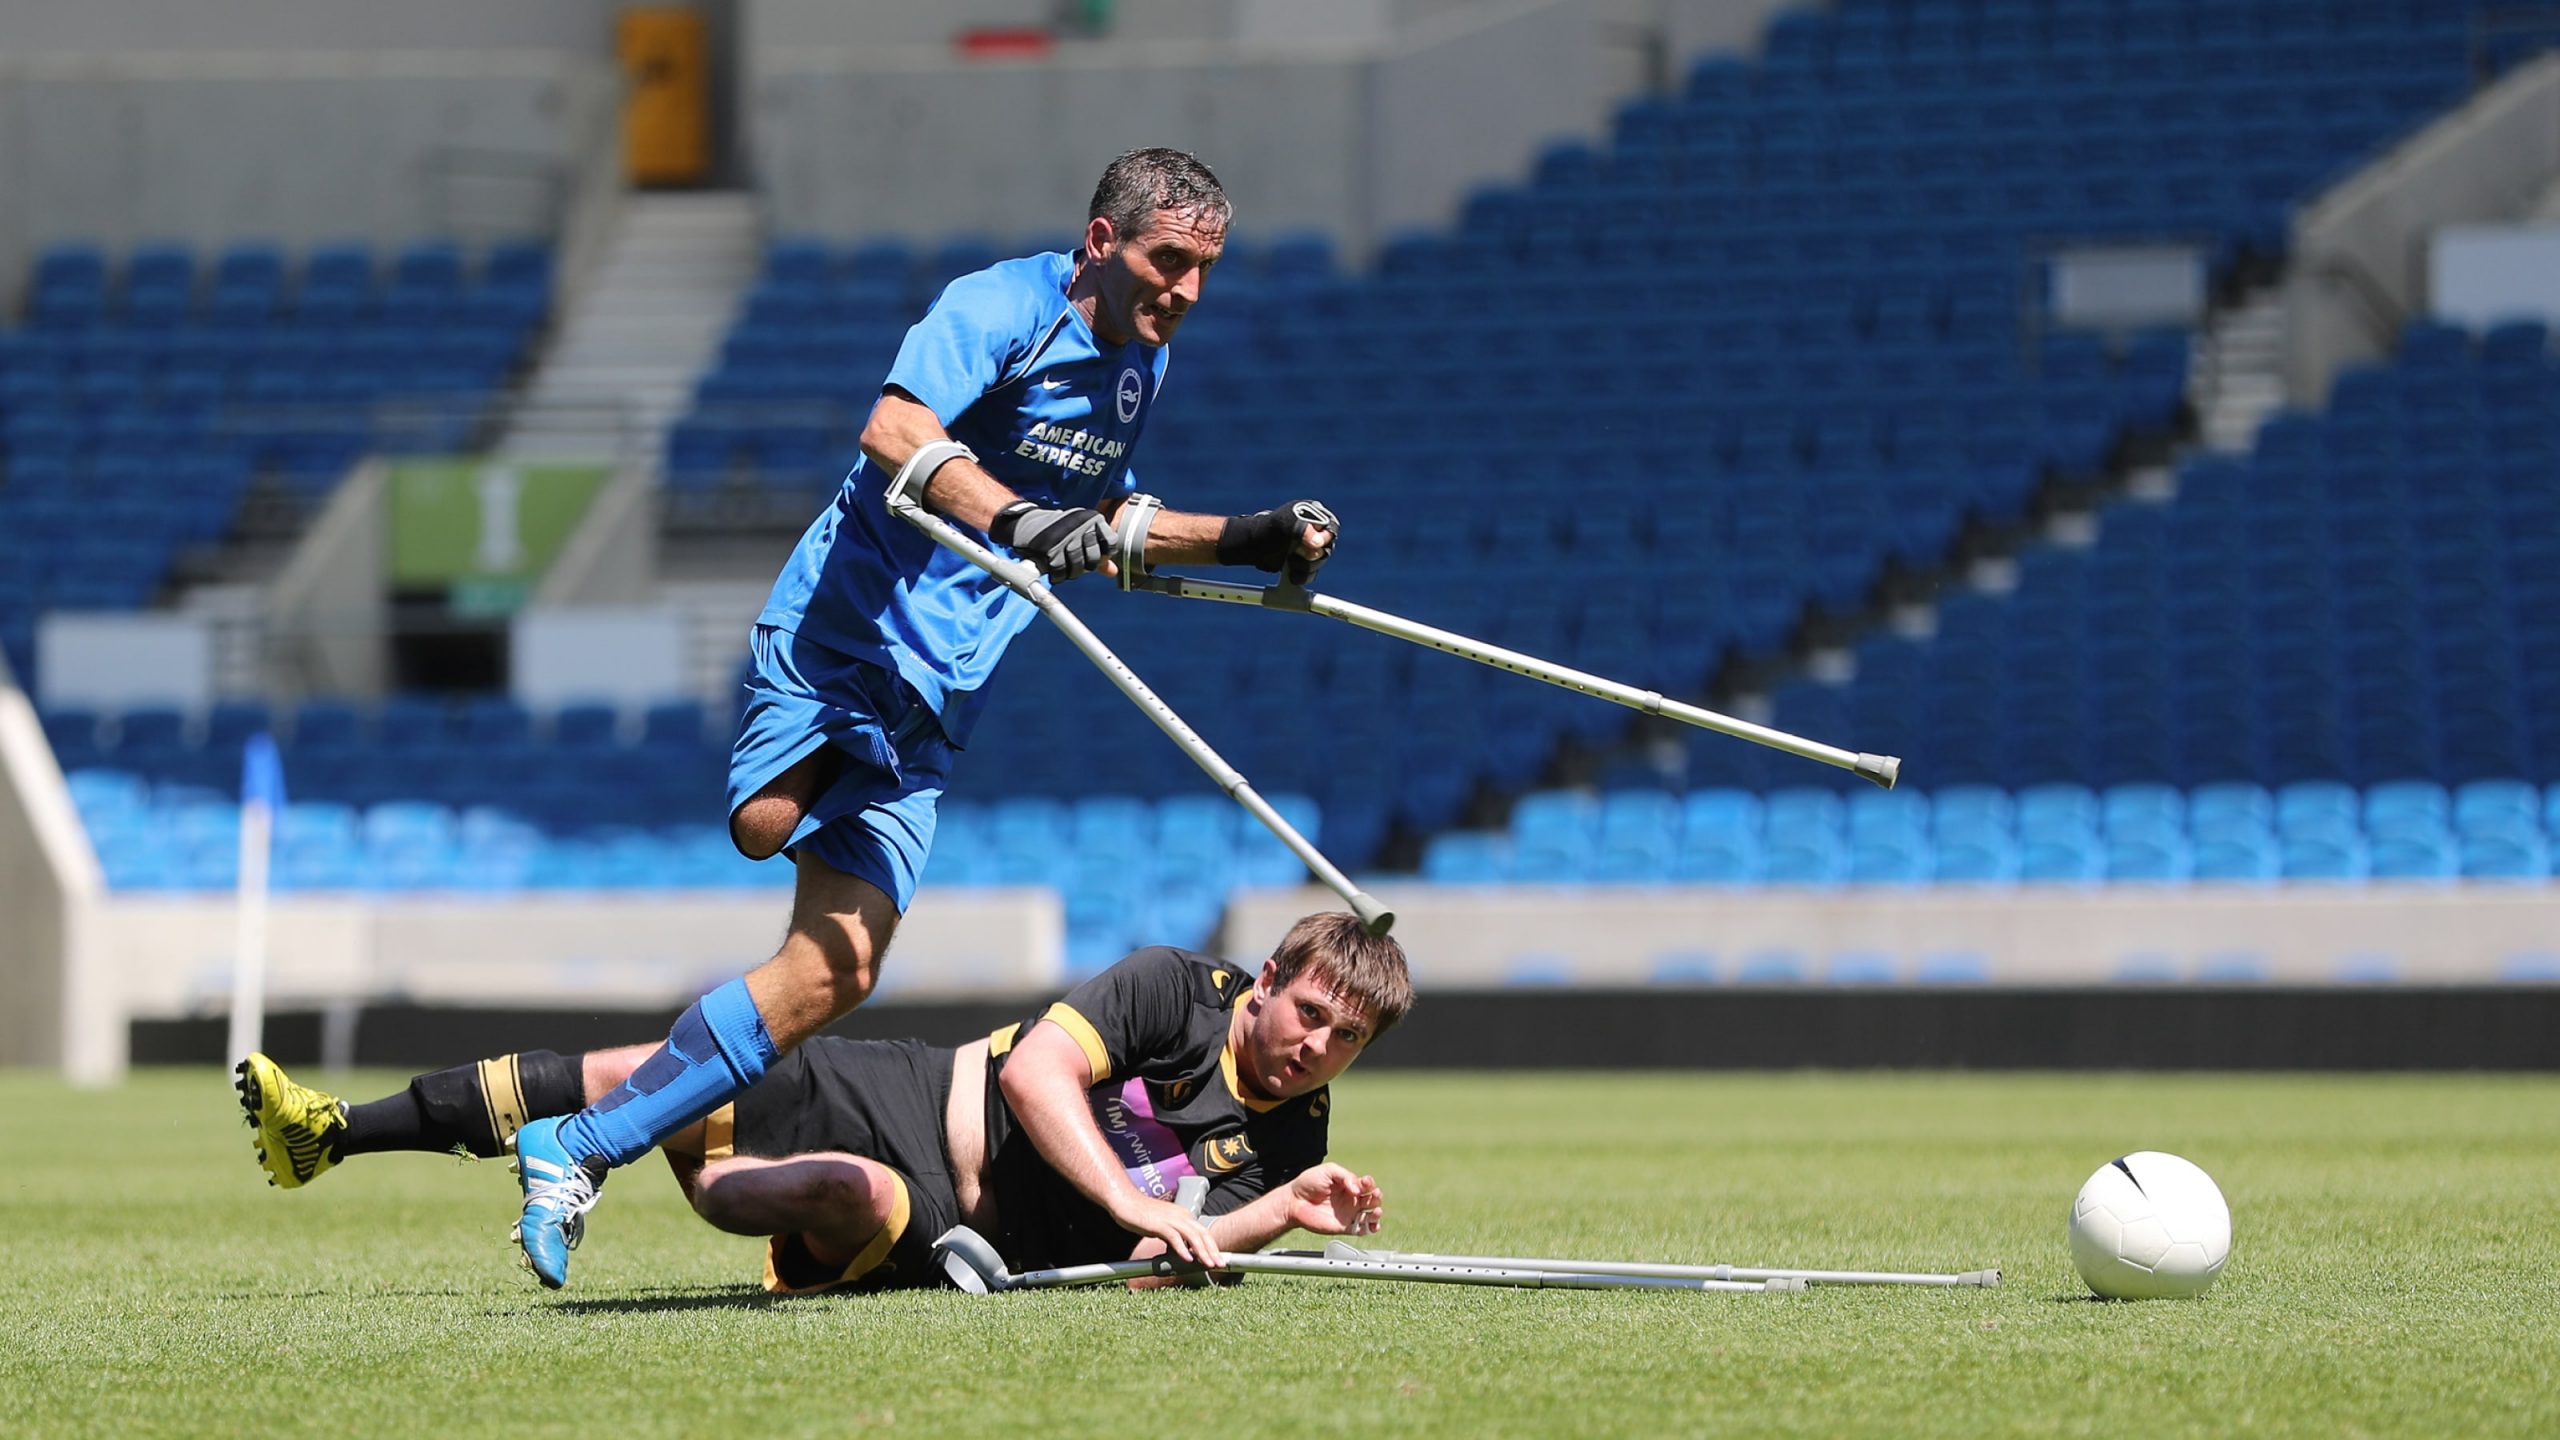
left=2284, top=54, right=2560, bottom=407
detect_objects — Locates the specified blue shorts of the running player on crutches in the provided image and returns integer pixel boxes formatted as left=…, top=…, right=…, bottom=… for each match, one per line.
left=730, top=625, right=952, bottom=915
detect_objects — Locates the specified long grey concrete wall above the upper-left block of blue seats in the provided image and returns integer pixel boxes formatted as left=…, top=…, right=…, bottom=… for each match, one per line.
left=0, top=51, right=617, bottom=292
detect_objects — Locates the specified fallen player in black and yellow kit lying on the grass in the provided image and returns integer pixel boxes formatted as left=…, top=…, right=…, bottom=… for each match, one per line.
left=241, top=915, right=1413, bottom=1294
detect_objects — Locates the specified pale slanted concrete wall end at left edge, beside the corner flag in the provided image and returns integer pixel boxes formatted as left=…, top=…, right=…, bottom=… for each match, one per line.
left=0, top=661, right=125, bottom=1084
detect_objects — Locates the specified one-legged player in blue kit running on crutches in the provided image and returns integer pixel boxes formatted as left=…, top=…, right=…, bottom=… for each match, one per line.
left=488, top=149, right=1336, bottom=1289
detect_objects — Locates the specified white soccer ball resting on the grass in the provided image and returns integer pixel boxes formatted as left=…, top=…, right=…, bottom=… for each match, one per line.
left=2071, top=1150, right=2232, bottom=1299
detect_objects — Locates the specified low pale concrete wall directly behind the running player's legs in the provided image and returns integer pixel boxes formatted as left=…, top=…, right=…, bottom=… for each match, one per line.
left=95, top=887, right=1068, bottom=1017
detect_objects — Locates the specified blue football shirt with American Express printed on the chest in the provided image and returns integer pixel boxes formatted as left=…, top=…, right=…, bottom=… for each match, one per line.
left=758, top=254, right=1165, bottom=746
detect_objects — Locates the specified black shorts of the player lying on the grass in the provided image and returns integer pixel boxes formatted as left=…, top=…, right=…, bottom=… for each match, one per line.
left=704, top=1035, right=960, bottom=1294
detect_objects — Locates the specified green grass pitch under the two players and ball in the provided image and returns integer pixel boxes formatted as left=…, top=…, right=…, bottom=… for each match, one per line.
left=0, top=1071, right=2560, bottom=1440
